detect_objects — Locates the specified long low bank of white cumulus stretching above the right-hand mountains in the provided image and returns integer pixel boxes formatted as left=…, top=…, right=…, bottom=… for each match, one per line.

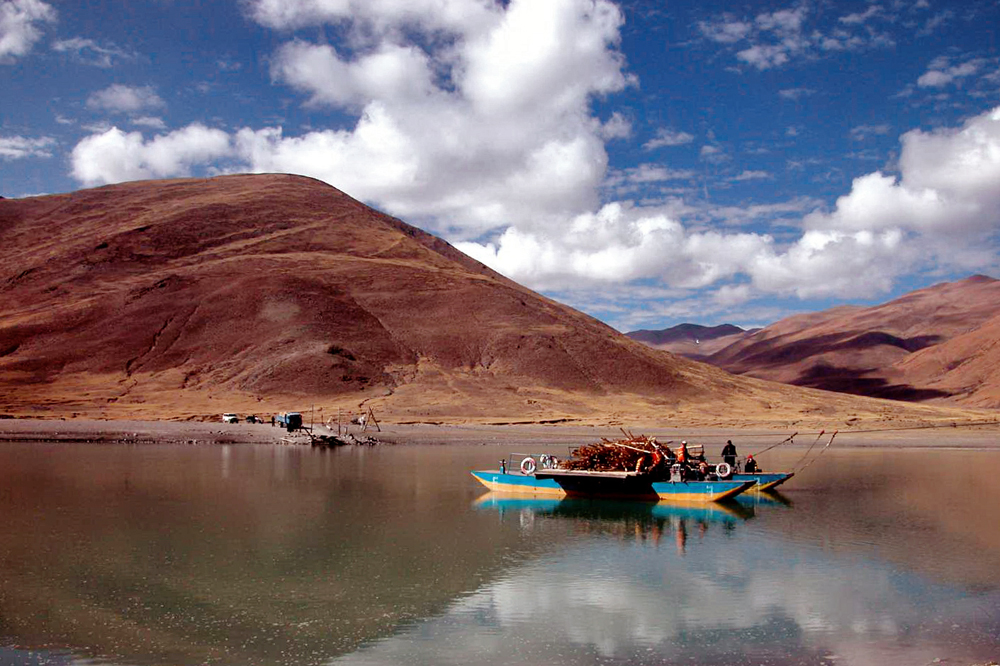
left=460, top=108, right=1000, bottom=299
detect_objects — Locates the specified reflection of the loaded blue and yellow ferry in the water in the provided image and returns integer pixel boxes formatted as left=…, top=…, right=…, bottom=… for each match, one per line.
left=473, top=493, right=752, bottom=554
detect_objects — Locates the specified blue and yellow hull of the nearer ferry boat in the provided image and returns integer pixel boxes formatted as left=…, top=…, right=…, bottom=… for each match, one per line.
left=472, top=468, right=757, bottom=502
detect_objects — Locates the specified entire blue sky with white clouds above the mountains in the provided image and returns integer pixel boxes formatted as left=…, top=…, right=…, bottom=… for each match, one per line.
left=0, top=0, right=1000, bottom=331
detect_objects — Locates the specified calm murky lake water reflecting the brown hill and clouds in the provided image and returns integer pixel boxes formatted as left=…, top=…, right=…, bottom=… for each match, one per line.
left=0, top=444, right=1000, bottom=666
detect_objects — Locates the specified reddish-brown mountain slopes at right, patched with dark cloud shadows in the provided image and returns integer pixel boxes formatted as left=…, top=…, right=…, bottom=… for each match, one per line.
left=705, top=275, right=1000, bottom=407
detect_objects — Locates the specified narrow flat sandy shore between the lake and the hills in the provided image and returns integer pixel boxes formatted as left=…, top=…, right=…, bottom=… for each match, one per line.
left=0, top=419, right=1000, bottom=454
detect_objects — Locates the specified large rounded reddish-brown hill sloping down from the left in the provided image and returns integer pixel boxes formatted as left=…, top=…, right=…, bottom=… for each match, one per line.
left=0, top=175, right=980, bottom=423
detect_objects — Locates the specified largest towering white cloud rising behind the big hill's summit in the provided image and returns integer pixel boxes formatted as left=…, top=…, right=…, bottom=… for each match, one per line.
left=229, top=0, right=633, bottom=236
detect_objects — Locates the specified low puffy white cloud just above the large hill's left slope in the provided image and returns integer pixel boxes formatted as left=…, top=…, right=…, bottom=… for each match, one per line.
left=71, top=123, right=232, bottom=185
